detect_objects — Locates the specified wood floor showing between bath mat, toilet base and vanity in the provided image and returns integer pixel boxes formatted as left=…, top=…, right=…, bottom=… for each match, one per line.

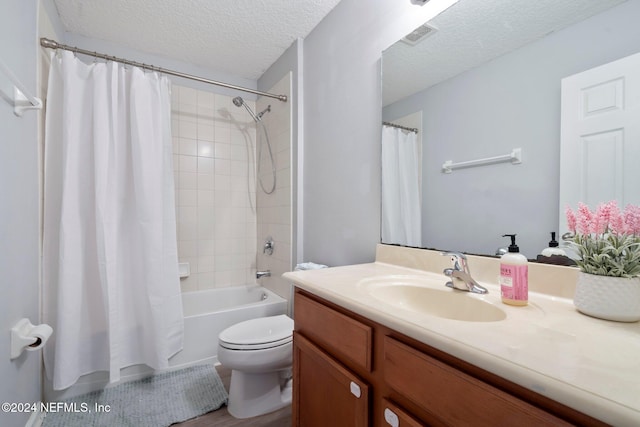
left=172, top=365, right=291, bottom=427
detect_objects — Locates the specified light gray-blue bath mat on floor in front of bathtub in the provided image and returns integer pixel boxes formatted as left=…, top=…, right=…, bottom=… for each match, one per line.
left=42, top=365, right=228, bottom=427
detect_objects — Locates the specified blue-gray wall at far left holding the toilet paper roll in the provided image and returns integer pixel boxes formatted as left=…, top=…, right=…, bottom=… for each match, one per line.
left=0, top=0, right=40, bottom=427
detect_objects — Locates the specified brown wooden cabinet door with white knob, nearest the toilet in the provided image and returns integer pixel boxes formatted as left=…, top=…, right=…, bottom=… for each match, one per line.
left=293, top=333, right=369, bottom=427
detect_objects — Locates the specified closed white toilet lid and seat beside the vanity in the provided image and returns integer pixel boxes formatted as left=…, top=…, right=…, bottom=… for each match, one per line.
left=218, top=314, right=293, bottom=350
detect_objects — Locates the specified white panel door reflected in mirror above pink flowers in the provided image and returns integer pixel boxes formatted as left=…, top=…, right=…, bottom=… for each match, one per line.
left=560, top=53, right=640, bottom=234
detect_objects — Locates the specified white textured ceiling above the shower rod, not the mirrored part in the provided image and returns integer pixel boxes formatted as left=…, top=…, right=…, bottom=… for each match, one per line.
left=54, top=0, right=339, bottom=80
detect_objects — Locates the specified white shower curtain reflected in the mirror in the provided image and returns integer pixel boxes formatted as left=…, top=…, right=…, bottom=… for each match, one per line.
left=382, top=126, right=422, bottom=247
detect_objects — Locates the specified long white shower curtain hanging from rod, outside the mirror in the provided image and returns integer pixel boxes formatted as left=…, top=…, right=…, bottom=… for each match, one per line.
left=43, top=52, right=183, bottom=390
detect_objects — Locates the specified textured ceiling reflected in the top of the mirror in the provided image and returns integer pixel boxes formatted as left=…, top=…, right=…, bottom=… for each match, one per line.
left=382, top=0, right=625, bottom=105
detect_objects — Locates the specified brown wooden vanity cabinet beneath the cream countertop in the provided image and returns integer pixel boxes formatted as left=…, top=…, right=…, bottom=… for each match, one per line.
left=293, top=288, right=605, bottom=427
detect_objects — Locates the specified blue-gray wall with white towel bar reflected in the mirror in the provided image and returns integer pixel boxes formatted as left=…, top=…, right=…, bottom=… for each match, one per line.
left=383, top=0, right=640, bottom=258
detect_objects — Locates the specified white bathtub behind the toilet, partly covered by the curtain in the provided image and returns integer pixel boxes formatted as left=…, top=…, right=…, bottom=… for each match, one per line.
left=43, top=285, right=287, bottom=402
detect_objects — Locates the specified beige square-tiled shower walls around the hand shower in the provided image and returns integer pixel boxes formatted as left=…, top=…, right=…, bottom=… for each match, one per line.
left=171, top=77, right=292, bottom=298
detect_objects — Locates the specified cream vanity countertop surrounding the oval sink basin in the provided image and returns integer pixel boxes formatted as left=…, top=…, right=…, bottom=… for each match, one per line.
left=284, top=262, right=640, bottom=426
